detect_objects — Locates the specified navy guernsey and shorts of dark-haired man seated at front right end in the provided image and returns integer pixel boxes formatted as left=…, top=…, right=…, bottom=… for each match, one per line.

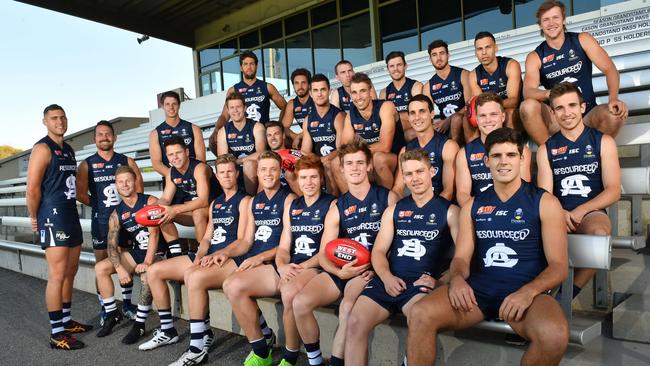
left=467, top=180, right=547, bottom=319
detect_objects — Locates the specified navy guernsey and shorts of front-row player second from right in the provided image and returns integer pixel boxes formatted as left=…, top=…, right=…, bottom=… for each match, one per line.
left=362, top=196, right=451, bottom=313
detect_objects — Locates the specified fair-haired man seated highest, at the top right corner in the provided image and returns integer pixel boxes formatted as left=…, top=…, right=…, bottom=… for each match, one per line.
left=520, top=1, right=628, bottom=146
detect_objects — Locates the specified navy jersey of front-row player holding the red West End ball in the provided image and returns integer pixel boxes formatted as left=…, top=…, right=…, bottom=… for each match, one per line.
left=336, top=184, right=390, bottom=250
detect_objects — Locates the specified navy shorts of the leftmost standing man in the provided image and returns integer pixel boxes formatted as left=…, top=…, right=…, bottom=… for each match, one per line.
left=37, top=206, right=83, bottom=249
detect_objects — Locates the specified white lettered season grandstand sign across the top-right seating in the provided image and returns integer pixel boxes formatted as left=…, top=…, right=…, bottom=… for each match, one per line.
left=580, top=7, right=650, bottom=46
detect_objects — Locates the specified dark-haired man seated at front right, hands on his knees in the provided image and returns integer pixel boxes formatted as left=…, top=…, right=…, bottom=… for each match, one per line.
left=407, top=127, right=569, bottom=366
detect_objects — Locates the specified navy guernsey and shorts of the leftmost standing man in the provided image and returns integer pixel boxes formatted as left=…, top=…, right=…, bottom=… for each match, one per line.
left=36, top=136, right=83, bottom=249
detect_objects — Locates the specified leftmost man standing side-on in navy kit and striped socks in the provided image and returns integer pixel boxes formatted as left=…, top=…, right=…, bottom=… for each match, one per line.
left=26, top=104, right=92, bottom=350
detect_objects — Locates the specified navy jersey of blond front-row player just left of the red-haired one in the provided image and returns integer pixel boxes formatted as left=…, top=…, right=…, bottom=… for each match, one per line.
left=246, top=187, right=291, bottom=257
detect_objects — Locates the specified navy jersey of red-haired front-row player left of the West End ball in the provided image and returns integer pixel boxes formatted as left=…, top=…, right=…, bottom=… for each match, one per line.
left=289, top=193, right=335, bottom=263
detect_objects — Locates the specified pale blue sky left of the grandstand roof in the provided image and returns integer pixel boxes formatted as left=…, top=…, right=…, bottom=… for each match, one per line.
left=0, top=1, right=196, bottom=149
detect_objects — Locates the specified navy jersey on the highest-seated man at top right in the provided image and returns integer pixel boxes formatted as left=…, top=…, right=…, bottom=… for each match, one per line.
left=531, top=32, right=596, bottom=113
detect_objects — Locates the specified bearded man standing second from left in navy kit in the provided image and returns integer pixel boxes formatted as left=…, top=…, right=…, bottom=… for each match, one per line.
left=77, top=121, right=144, bottom=322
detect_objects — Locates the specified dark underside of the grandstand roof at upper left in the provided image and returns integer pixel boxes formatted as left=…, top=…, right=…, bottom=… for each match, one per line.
left=18, top=0, right=258, bottom=48
